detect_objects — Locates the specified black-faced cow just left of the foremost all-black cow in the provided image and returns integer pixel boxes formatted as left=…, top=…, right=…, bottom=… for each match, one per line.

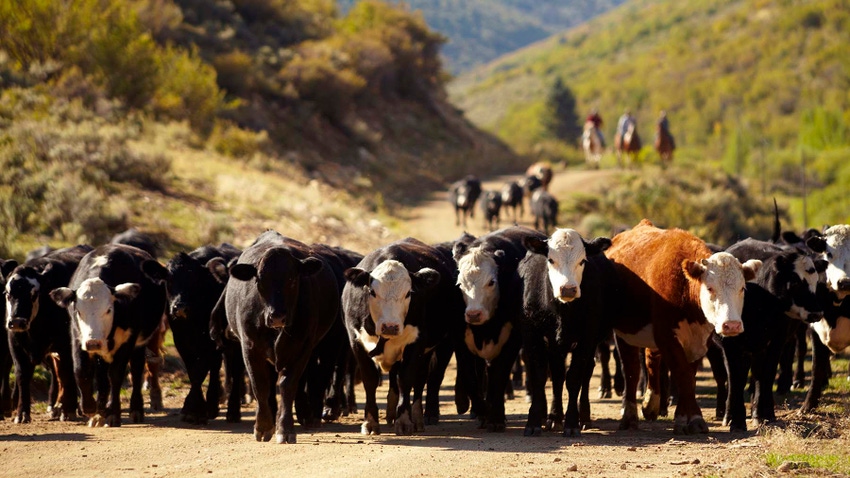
left=165, top=243, right=242, bottom=424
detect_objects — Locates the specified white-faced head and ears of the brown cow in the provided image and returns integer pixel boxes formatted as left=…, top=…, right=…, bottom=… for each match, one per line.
left=682, top=252, right=761, bottom=337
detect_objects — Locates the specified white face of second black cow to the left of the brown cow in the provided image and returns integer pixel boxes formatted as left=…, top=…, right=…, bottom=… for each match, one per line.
left=457, top=247, right=499, bottom=324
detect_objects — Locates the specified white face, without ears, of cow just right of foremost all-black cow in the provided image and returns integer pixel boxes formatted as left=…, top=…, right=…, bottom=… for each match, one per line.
left=368, top=260, right=412, bottom=338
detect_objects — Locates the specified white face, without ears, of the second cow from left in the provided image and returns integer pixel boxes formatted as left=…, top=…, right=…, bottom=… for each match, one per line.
left=75, top=278, right=115, bottom=351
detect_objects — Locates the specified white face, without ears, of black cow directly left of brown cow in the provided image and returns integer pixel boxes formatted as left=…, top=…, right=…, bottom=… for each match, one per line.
left=547, top=229, right=587, bottom=303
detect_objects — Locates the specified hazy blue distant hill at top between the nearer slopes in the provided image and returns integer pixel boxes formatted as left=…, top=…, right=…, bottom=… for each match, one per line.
left=339, top=0, right=625, bottom=74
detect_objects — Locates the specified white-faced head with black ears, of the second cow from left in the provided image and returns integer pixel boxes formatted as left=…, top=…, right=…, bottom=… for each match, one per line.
left=50, top=277, right=142, bottom=355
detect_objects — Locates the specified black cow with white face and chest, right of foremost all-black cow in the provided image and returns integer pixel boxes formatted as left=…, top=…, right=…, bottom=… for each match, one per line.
left=342, top=238, right=463, bottom=435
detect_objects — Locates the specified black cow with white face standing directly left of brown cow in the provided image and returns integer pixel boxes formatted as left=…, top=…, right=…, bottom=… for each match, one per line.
left=519, top=229, right=617, bottom=436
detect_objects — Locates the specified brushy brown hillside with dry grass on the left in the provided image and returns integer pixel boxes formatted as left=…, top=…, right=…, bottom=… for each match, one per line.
left=0, top=0, right=524, bottom=257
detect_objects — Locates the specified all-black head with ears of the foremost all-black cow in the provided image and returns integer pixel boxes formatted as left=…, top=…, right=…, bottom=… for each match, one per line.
left=230, top=247, right=324, bottom=329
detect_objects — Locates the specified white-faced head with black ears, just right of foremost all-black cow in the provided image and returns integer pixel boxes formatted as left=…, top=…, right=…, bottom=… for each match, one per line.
left=345, top=260, right=440, bottom=339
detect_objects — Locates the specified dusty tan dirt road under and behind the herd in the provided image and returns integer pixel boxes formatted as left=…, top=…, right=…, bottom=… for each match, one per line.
left=0, top=167, right=788, bottom=478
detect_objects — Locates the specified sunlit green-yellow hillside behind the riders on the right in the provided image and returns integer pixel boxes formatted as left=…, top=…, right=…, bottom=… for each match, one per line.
left=449, top=0, right=850, bottom=227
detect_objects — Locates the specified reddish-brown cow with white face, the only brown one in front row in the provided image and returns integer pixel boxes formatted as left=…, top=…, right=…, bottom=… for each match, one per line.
left=606, top=219, right=761, bottom=434
